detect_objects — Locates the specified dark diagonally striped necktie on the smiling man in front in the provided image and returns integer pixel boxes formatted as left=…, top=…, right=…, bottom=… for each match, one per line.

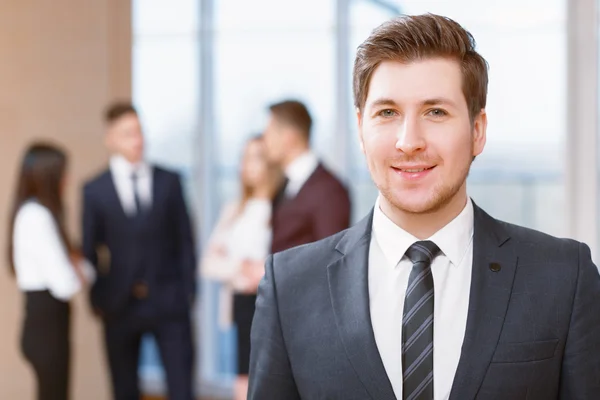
left=402, top=241, right=440, bottom=400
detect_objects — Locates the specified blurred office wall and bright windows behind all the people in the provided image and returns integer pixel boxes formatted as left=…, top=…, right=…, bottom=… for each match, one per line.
left=0, top=0, right=600, bottom=400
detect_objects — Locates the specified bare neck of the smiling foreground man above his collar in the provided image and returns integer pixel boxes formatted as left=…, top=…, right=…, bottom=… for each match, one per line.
left=380, top=189, right=469, bottom=240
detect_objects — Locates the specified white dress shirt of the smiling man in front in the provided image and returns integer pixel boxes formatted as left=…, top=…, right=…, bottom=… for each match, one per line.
left=368, top=198, right=474, bottom=400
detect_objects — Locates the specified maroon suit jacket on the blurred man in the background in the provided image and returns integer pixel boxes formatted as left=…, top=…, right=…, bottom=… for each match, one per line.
left=271, top=164, right=350, bottom=253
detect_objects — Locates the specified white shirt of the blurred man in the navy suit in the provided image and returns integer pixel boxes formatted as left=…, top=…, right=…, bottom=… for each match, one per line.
left=110, top=155, right=152, bottom=215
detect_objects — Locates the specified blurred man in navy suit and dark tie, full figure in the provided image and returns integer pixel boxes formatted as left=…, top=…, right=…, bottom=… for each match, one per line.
left=83, top=103, right=196, bottom=400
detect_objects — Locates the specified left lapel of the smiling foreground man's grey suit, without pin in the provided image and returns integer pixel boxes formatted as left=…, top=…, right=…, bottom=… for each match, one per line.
left=327, top=213, right=396, bottom=400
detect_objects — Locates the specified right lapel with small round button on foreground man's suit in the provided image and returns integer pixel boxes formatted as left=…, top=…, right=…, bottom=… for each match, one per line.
left=450, top=205, right=517, bottom=400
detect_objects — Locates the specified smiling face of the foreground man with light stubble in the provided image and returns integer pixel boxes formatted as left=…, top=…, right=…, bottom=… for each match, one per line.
left=358, top=58, right=487, bottom=213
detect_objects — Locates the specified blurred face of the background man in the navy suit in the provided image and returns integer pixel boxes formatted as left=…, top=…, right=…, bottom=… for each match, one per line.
left=106, top=113, right=144, bottom=163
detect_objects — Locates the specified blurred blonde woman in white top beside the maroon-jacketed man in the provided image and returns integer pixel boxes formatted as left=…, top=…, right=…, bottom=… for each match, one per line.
left=201, top=136, right=282, bottom=400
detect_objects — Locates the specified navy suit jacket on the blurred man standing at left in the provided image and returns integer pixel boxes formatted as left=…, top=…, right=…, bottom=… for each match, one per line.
left=83, top=167, right=196, bottom=317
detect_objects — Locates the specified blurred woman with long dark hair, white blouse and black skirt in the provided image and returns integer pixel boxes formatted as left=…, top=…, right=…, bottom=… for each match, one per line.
left=8, top=143, right=94, bottom=400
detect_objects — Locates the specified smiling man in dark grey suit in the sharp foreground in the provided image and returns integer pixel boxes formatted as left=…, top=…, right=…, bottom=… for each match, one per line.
left=249, top=14, right=600, bottom=400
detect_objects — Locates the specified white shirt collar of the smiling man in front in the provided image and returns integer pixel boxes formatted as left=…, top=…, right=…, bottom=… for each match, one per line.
left=372, top=197, right=474, bottom=267
